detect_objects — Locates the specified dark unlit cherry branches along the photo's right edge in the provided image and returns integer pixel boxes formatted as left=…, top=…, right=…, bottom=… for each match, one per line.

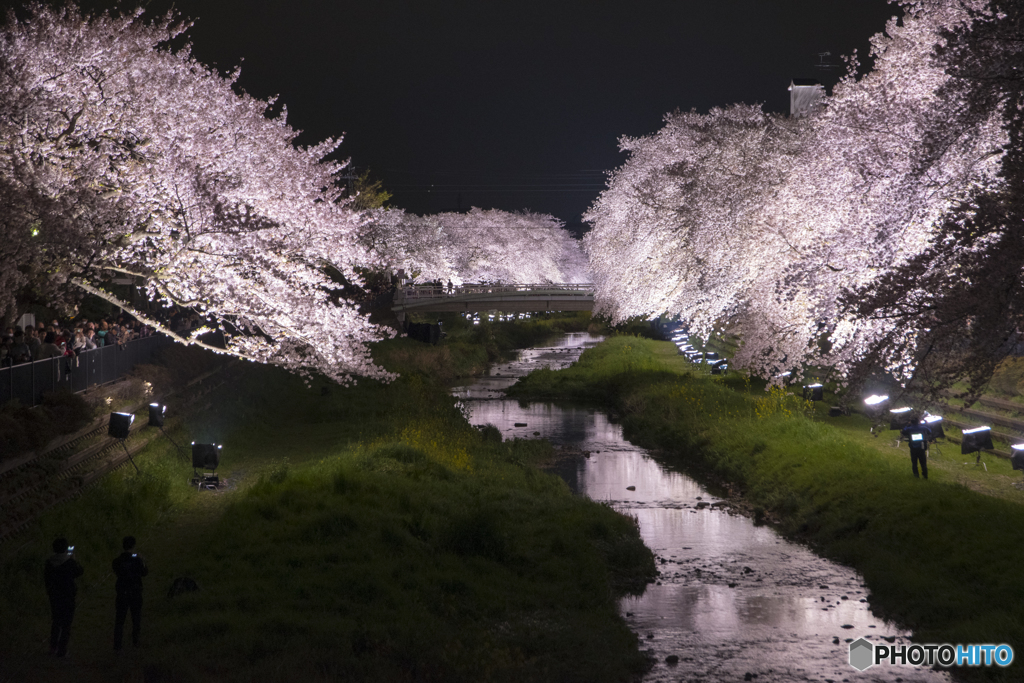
left=842, top=0, right=1024, bottom=401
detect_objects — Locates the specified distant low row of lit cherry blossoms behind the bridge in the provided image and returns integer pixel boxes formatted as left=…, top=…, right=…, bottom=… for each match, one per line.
left=365, top=208, right=590, bottom=284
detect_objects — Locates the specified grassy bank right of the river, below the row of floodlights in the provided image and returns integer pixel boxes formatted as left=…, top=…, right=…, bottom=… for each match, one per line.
left=512, top=337, right=1024, bottom=680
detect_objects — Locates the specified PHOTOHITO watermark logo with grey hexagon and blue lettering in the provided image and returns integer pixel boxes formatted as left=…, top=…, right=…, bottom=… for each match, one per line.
left=850, top=638, right=1014, bottom=671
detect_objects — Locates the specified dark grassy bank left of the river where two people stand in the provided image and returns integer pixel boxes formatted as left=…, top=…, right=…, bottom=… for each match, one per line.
left=0, top=329, right=654, bottom=681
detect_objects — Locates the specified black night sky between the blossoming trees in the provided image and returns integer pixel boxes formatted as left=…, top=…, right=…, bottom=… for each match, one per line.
left=75, top=0, right=898, bottom=235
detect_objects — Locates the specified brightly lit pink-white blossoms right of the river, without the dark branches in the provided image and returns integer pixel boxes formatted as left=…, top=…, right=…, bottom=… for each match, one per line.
left=585, top=0, right=1009, bottom=393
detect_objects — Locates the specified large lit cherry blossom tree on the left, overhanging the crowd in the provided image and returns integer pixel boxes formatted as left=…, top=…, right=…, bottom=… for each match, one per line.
left=0, top=4, right=388, bottom=382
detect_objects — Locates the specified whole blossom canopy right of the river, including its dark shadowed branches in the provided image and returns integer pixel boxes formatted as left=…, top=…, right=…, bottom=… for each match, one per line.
left=585, top=0, right=1024, bottom=395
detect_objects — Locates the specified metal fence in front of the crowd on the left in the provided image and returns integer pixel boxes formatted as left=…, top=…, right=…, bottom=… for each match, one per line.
left=0, top=335, right=174, bottom=405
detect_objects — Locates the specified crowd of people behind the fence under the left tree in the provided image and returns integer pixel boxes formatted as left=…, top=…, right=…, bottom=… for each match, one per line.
left=0, top=315, right=153, bottom=367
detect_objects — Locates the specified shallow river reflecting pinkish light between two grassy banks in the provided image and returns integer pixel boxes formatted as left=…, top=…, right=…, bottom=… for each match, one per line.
left=453, top=333, right=950, bottom=683
